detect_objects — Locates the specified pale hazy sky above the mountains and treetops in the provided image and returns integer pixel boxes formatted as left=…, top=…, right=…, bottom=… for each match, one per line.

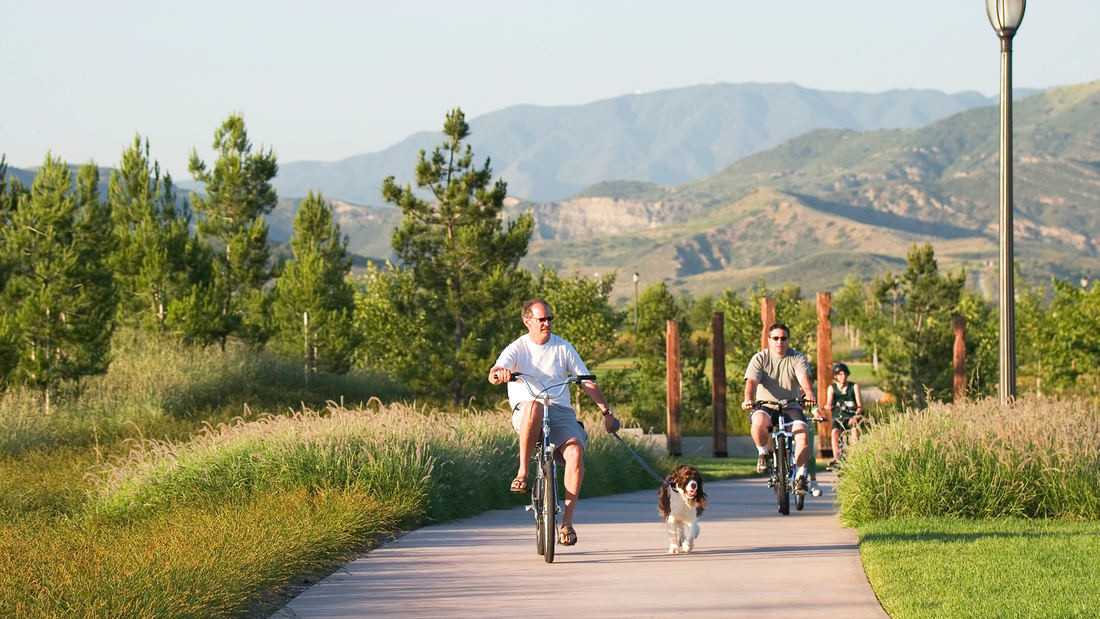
left=0, top=0, right=1100, bottom=178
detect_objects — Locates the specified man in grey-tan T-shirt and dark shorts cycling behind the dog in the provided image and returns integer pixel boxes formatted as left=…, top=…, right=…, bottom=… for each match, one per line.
left=741, top=322, right=814, bottom=493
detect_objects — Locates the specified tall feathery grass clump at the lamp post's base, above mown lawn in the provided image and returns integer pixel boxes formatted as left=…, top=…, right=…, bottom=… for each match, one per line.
left=839, top=398, right=1100, bottom=526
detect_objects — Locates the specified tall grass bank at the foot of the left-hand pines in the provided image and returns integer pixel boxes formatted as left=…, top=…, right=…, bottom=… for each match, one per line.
left=0, top=330, right=404, bottom=455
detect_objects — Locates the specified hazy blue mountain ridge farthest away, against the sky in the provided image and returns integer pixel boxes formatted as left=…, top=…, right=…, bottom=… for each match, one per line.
left=275, top=84, right=992, bottom=205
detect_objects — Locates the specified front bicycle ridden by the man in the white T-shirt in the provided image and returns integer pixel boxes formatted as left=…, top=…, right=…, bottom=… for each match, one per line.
left=512, top=372, right=596, bottom=563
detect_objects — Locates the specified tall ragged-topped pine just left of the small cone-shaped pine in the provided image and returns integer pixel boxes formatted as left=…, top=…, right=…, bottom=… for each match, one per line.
left=187, top=114, right=278, bottom=347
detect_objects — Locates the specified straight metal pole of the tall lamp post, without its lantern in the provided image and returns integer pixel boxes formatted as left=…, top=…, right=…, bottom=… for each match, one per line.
left=999, top=34, right=1016, bottom=406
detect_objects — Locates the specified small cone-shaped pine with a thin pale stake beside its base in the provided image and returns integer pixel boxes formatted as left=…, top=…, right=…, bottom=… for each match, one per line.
left=272, top=192, right=359, bottom=374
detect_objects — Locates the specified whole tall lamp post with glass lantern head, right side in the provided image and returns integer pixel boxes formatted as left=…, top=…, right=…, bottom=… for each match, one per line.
left=986, top=0, right=1026, bottom=405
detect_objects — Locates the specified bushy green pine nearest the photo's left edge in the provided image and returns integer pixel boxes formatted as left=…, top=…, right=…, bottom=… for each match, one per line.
left=2, top=155, right=114, bottom=412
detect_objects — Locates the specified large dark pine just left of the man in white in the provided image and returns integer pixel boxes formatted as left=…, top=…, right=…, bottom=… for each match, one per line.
left=382, top=109, right=532, bottom=401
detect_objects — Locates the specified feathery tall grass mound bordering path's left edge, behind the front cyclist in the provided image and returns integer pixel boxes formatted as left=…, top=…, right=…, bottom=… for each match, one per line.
left=90, top=404, right=660, bottom=521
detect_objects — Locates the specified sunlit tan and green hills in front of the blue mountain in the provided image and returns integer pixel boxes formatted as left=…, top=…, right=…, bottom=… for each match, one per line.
left=523, top=81, right=1100, bottom=295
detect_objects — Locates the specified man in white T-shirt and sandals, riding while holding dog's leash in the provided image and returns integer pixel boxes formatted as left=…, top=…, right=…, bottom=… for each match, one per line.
left=488, top=299, right=619, bottom=545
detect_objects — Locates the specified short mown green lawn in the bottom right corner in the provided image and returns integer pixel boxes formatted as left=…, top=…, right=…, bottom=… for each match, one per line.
left=859, top=518, right=1100, bottom=619
